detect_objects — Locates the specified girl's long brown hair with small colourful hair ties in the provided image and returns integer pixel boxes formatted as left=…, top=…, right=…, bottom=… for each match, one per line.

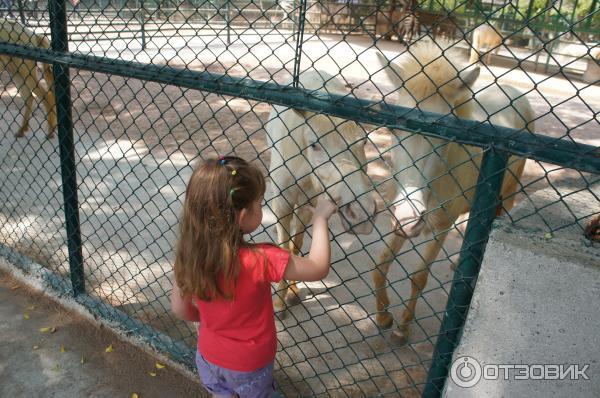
left=174, top=156, right=265, bottom=301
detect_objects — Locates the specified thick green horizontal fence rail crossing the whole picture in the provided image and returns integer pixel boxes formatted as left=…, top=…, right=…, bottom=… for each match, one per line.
left=0, top=44, right=600, bottom=173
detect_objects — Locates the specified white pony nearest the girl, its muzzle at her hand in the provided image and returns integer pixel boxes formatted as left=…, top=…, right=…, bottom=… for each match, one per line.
left=266, top=70, right=376, bottom=310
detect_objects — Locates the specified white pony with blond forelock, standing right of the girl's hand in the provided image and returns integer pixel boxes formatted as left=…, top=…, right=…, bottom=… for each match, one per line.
left=373, top=43, right=534, bottom=345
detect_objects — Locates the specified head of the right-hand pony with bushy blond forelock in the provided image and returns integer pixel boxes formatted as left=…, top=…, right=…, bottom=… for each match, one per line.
left=377, top=43, right=480, bottom=238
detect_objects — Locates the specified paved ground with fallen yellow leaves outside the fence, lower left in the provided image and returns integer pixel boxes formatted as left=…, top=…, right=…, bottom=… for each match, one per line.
left=0, top=271, right=205, bottom=398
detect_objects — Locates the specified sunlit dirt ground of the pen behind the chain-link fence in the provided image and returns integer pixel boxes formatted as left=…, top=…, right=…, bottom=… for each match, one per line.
left=0, top=31, right=600, bottom=396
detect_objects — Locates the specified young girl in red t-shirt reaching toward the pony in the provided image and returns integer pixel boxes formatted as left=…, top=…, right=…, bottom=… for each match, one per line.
left=171, top=156, right=336, bottom=398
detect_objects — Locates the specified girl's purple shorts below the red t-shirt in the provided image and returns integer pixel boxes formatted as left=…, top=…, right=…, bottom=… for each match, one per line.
left=196, top=351, right=280, bottom=398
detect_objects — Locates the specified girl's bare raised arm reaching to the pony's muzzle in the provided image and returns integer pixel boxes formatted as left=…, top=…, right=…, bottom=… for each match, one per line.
left=283, top=198, right=337, bottom=282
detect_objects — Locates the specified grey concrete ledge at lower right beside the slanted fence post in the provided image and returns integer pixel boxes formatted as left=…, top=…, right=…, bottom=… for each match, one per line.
left=444, top=188, right=600, bottom=398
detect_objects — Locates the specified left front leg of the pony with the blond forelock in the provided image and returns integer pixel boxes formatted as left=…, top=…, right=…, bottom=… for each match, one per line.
left=373, top=234, right=406, bottom=329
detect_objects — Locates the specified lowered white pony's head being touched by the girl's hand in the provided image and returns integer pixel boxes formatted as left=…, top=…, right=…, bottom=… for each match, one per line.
left=294, top=110, right=377, bottom=234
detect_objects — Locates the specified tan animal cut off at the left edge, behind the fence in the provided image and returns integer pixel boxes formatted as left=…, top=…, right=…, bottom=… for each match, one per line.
left=0, top=19, right=56, bottom=138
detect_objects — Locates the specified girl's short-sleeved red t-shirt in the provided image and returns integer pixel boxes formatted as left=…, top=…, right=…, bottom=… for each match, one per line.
left=195, top=244, right=290, bottom=372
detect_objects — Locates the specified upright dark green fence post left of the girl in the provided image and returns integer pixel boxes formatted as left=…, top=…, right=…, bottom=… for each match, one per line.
left=49, top=0, right=85, bottom=296
